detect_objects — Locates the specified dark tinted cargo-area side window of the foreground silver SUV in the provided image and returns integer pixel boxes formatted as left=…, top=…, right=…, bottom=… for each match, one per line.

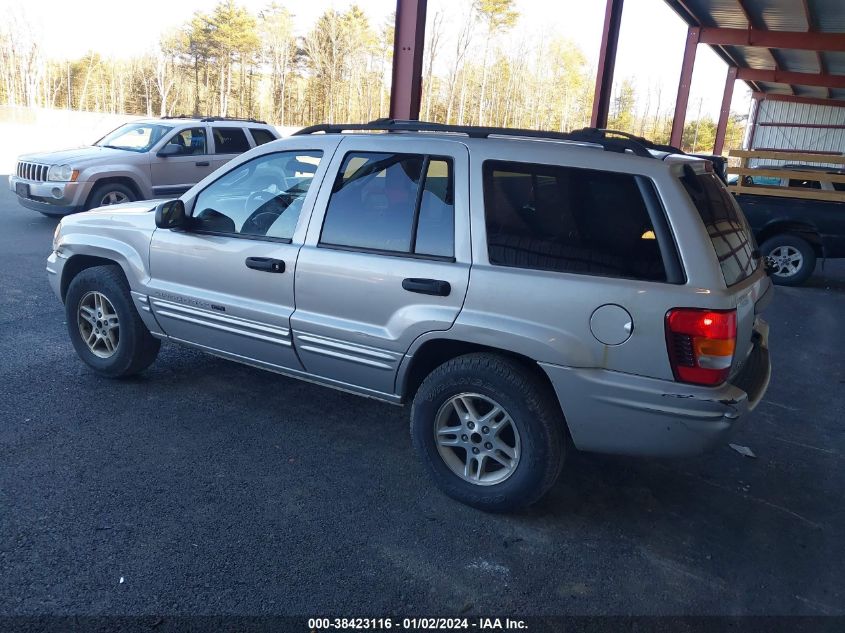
left=483, top=161, right=666, bottom=281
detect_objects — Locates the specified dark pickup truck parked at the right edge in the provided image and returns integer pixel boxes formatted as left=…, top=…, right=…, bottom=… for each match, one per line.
left=732, top=165, right=845, bottom=286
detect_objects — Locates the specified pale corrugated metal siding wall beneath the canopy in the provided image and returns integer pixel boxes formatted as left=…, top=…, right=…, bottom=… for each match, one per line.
left=752, top=101, right=845, bottom=167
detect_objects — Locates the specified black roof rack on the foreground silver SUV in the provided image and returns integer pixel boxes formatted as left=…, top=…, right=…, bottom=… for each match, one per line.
left=293, top=119, right=656, bottom=158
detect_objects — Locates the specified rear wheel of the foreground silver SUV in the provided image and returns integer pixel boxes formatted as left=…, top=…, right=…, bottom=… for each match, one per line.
left=411, top=353, right=565, bottom=512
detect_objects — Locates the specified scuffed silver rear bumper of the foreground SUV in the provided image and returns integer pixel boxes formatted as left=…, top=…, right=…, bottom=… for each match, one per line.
left=541, top=321, right=771, bottom=457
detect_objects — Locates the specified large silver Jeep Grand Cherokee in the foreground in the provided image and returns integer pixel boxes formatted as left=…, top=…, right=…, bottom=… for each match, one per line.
left=47, top=120, right=772, bottom=510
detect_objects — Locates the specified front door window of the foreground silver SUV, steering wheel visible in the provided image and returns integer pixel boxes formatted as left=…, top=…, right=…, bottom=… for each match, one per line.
left=191, top=151, right=323, bottom=240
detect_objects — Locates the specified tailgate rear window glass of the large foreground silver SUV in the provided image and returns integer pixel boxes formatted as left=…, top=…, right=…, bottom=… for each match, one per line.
left=681, top=173, right=757, bottom=286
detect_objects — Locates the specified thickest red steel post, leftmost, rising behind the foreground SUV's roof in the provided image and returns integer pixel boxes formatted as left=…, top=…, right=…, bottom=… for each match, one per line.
left=390, top=0, right=428, bottom=119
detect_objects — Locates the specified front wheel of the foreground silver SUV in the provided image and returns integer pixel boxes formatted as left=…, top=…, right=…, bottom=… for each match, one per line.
left=65, top=266, right=161, bottom=378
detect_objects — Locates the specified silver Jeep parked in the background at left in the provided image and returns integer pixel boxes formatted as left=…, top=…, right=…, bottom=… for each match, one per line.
left=9, top=117, right=279, bottom=215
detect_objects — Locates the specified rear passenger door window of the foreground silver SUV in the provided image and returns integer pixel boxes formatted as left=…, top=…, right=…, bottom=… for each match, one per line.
left=320, top=152, right=455, bottom=258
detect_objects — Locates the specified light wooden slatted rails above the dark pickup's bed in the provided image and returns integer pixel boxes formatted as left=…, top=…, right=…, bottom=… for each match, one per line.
left=728, top=150, right=845, bottom=202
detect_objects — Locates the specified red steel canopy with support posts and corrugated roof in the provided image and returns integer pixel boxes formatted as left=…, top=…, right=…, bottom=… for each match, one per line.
left=390, top=0, right=845, bottom=154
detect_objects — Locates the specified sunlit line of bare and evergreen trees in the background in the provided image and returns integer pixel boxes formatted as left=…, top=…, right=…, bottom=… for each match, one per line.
left=0, top=0, right=744, bottom=151
